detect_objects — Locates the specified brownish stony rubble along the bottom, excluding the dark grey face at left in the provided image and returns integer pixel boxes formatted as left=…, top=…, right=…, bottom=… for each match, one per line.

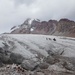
left=0, top=53, right=75, bottom=75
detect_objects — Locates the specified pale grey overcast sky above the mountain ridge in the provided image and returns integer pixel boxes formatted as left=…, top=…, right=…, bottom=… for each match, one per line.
left=0, top=0, right=75, bottom=33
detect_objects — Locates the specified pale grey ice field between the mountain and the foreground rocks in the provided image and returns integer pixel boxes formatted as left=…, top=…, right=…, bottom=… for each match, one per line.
left=0, top=34, right=75, bottom=59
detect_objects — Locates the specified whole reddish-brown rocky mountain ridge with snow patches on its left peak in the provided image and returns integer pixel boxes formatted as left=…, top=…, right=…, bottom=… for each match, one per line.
left=11, top=18, right=75, bottom=37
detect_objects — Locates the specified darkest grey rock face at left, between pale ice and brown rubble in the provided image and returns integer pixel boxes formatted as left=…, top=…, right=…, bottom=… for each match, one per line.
left=0, top=48, right=24, bottom=66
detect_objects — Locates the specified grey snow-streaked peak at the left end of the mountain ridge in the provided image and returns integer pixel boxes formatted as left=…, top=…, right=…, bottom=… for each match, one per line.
left=10, top=18, right=40, bottom=34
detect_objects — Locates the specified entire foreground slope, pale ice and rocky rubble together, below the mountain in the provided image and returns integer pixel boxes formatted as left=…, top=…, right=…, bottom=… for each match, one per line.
left=0, top=34, right=75, bottom=75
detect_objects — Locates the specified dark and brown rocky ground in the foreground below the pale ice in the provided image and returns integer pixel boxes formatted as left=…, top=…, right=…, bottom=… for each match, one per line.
left=0, top=44, right=75, bottom=75
